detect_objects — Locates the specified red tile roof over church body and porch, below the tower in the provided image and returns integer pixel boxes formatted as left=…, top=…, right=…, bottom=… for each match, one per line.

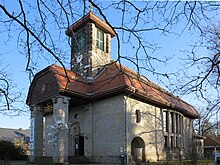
left=29, top=62, right=199, bottom=118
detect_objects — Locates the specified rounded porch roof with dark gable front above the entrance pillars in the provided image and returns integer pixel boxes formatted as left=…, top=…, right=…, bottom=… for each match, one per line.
left=26, top=64, right=87, bottom=105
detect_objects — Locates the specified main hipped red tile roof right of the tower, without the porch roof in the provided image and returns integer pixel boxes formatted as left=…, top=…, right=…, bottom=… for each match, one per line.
left=92, top=63, right=199, bottom=118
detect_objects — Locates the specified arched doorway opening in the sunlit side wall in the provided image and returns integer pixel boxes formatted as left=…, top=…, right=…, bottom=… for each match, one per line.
left=131, top=137, right=146, bottom=162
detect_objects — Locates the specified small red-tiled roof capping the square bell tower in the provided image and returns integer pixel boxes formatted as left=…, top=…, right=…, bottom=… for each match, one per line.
left=66, top=11, right=115, bottom=37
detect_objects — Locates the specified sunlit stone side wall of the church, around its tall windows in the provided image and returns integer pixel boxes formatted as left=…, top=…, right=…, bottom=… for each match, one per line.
left=125, top=97, right=192, bottom=162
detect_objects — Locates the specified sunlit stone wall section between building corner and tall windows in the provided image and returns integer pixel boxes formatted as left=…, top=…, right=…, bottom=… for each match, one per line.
left=126, top=97, right=164, bottom=161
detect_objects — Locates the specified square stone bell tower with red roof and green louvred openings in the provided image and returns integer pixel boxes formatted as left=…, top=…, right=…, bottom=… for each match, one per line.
left=66, top=11, right=115, bottom=80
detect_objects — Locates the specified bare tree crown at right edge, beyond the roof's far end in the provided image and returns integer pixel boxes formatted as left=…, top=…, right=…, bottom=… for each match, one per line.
left=172, top=25, right=220, bottom=113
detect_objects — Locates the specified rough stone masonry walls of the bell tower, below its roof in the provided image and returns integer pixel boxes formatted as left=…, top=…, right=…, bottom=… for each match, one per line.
left=71, top=22, right=111, bottom=79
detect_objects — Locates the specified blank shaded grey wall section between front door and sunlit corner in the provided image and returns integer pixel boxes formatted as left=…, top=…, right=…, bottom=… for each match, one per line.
left=93, top=95, right=125, bottom=156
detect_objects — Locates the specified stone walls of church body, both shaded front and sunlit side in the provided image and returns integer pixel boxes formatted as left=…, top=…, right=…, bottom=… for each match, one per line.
left=41, top=95, right=192, bottom=163
